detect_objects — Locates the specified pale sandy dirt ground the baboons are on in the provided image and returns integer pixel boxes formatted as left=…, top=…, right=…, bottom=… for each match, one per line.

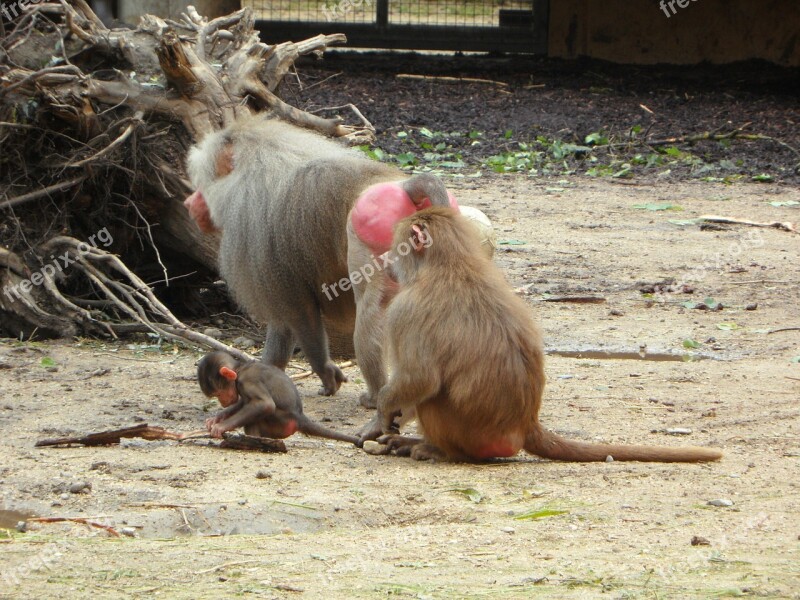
left=0, top=176, right=800, bottom=599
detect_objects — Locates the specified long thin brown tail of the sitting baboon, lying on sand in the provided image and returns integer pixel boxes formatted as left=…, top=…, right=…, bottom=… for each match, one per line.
left=524, top=425, right=722, bottom=462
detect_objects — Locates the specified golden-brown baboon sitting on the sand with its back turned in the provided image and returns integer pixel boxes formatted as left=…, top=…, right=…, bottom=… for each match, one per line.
left=362, top=208, right=722, bottom=462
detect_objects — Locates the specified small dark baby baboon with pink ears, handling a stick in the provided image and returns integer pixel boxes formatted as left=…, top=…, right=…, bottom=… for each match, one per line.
left=197, top=352, right=358, bottom=444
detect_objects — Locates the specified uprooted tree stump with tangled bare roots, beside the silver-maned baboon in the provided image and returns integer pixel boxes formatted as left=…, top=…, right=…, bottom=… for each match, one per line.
left=0, top=0, right=374, bottom=354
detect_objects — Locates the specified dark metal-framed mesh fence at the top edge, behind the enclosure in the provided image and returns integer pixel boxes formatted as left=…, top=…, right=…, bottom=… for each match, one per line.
left=248, top=0, right=549, bottom=53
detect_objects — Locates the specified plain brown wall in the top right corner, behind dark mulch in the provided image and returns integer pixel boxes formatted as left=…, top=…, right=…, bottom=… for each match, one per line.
left=548, top=0, right=800, bottom=67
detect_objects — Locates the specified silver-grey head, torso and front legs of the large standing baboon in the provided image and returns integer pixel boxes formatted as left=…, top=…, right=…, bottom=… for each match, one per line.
left=184, top=116, right=450, bottom=396
